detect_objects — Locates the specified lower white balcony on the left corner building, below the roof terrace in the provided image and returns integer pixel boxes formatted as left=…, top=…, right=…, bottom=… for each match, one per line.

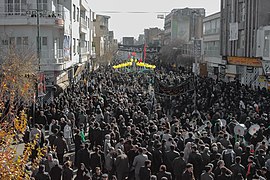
left=40, top=49, right=65, bottom=71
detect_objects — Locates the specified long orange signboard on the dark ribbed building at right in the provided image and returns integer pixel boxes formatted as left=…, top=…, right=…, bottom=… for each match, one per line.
left=228, top=56, right=262, bottom=67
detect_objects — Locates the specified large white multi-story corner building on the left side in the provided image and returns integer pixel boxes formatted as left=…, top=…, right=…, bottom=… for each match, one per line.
left=0, top=0, right=92, bottom=94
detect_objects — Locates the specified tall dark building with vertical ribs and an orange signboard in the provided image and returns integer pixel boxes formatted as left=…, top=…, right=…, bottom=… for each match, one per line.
left=220, top=0, right=270, bottom=87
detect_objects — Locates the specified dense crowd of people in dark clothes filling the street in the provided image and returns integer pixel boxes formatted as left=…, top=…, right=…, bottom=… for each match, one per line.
left=24, top=60, right=270, bottom=180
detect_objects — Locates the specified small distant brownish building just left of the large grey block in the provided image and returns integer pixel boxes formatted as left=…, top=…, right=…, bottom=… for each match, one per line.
left=144, top=27, right=164, bottom=46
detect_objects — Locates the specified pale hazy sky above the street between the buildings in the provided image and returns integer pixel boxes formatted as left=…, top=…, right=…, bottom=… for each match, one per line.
left=89, top=0, right=220, bottom=40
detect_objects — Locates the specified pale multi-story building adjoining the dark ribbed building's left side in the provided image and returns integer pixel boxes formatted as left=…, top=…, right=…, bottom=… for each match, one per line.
left=203, top=12, right=226, bottom=79
